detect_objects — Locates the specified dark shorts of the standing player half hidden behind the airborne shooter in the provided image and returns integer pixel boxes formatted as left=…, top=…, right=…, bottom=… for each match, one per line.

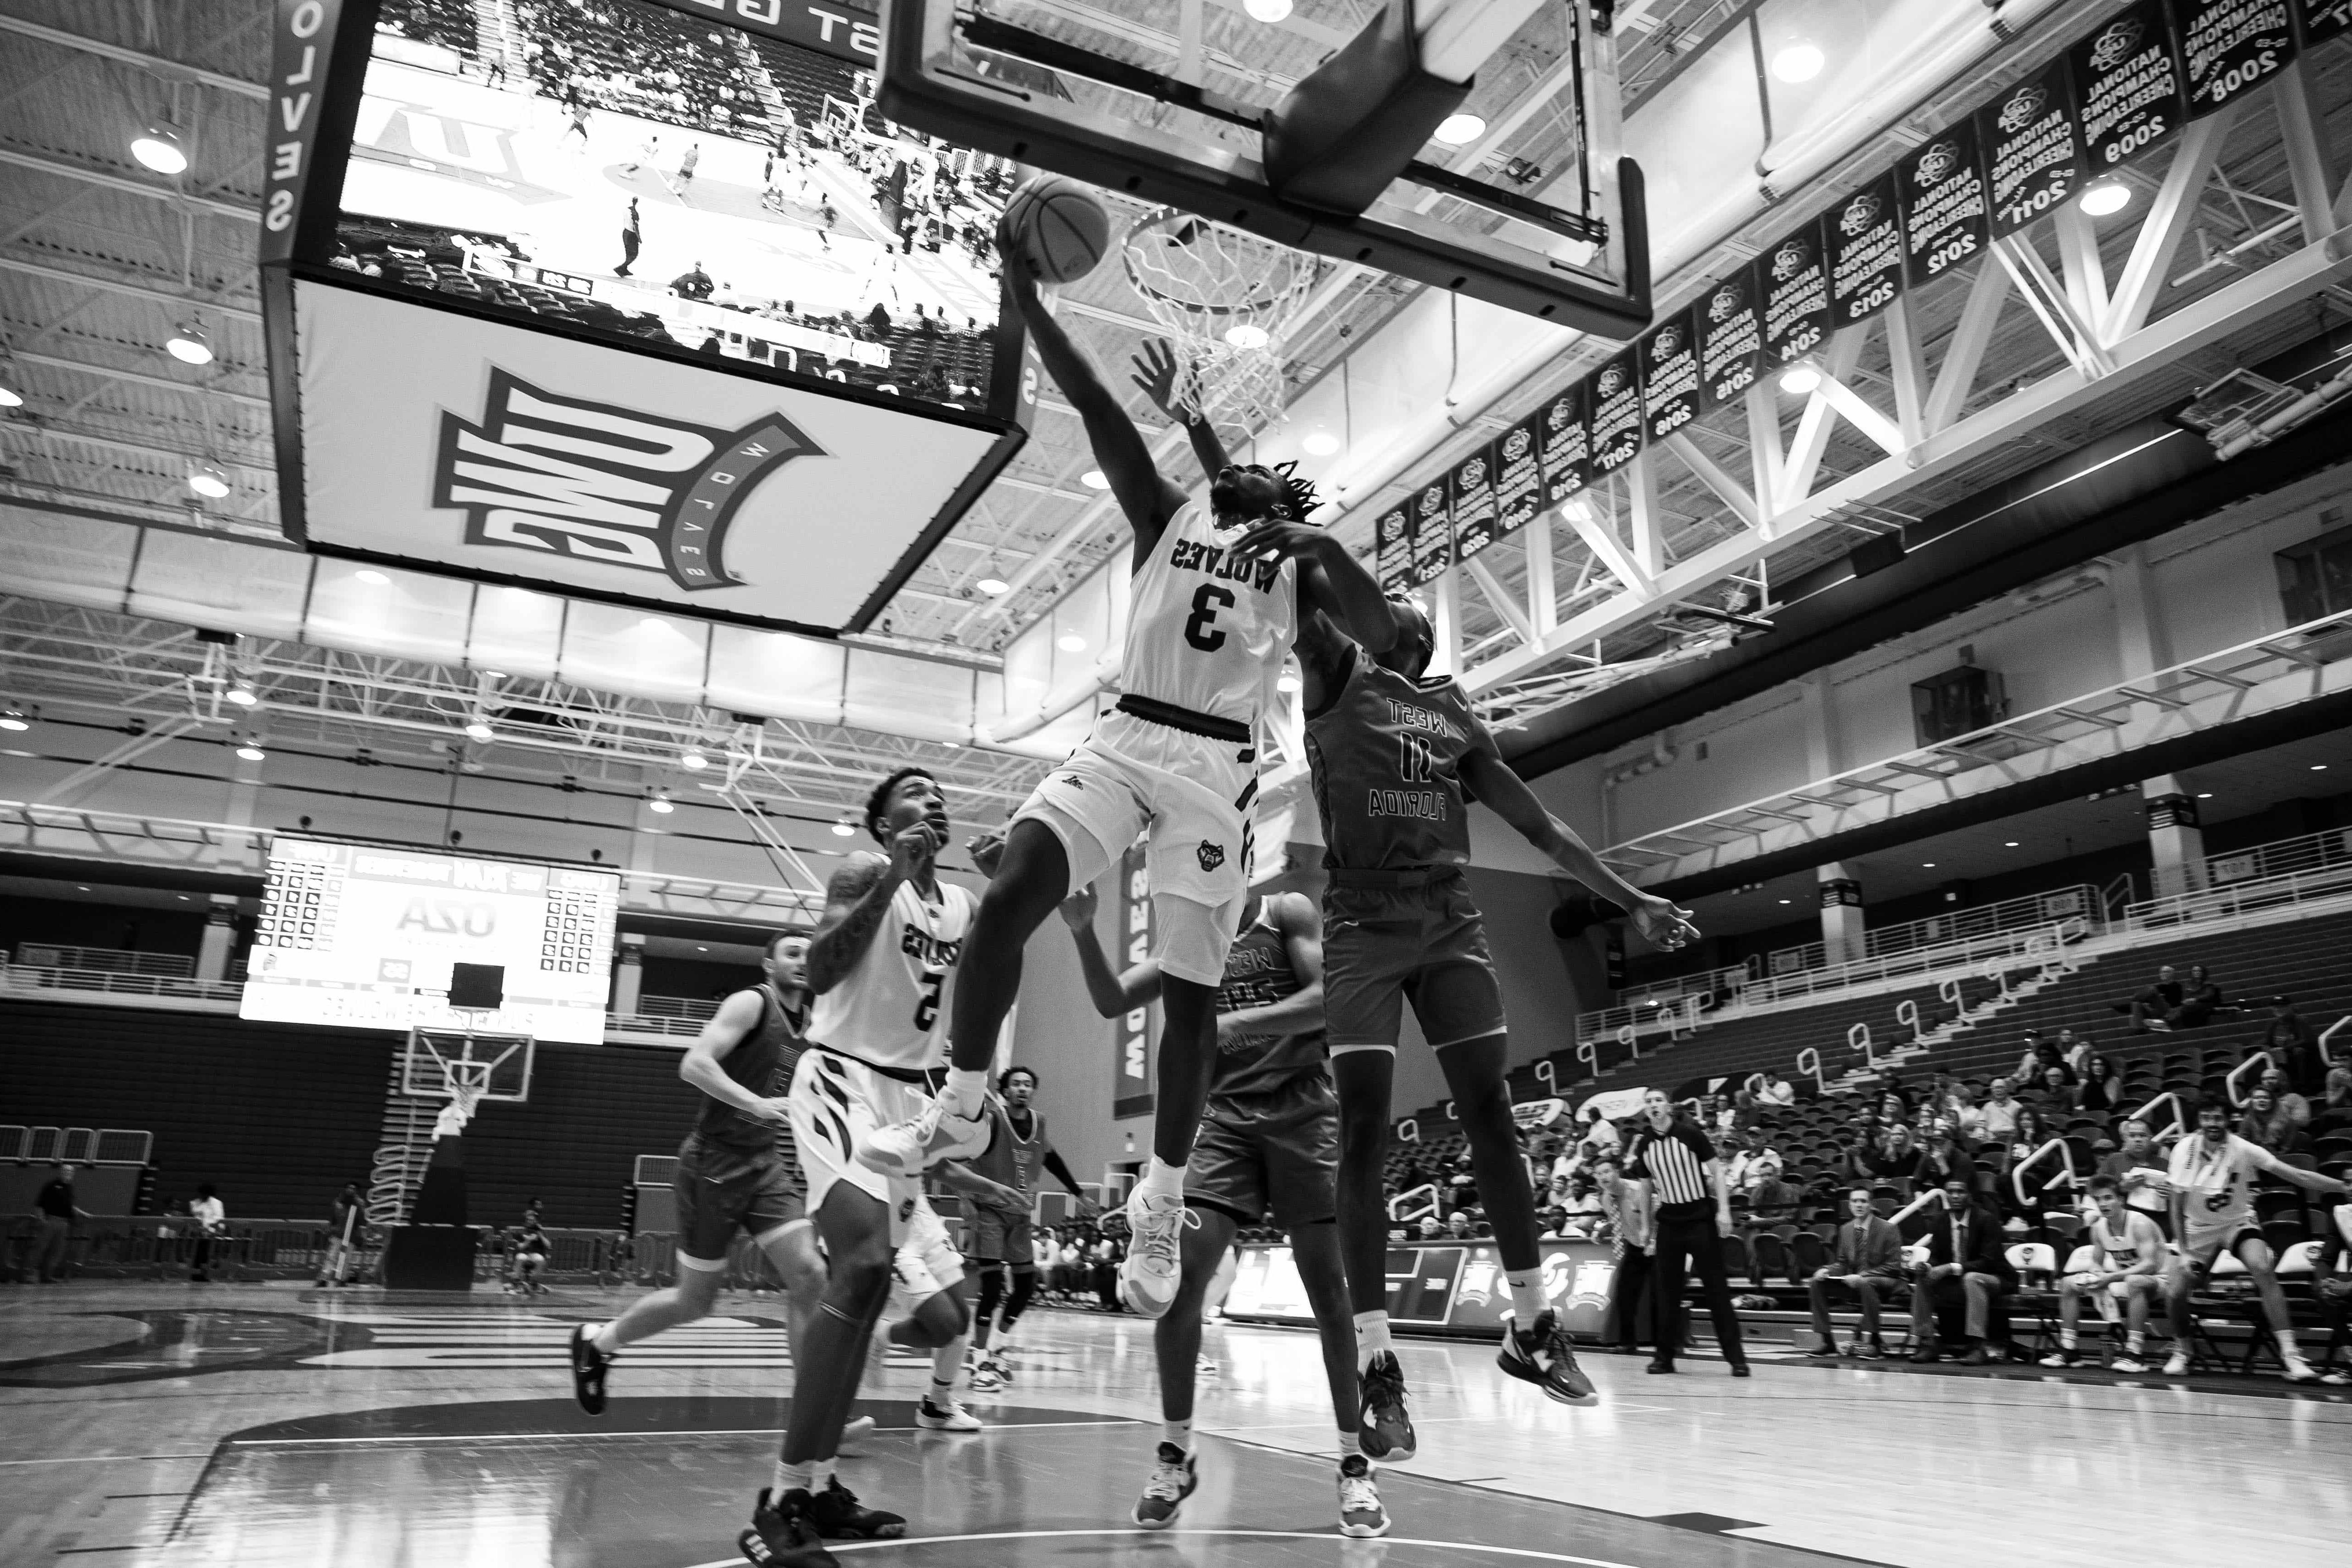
left=1183, top=1072, right=1338, bottom=1229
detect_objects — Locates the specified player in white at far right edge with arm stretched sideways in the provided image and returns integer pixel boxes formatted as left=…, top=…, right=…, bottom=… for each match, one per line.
left=2164, top=1105, right=2345, bottom=1382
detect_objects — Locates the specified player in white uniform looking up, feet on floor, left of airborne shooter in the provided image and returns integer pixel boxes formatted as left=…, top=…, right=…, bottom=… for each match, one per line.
left=739, top=769, right=974, bottom=1561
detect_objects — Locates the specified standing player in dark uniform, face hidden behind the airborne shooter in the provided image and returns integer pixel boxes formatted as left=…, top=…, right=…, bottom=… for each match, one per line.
left=1061, top=886, right=1387, bottom=1535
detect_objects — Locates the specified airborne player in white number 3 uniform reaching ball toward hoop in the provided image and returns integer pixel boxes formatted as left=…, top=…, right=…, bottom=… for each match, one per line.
left=859, top=215, right=1387, bottom=1317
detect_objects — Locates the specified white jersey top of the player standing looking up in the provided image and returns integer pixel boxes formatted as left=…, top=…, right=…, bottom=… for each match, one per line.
left=809, top=881, right=974, bottom=1072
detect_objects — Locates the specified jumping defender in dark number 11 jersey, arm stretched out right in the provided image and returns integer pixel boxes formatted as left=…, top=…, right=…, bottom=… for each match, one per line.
left=1244, top=592, right=1696, bottom=1460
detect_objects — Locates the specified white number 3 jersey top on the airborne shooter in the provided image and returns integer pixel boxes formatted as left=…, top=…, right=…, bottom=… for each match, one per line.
left=1120, top=503, right=1299, bottom=726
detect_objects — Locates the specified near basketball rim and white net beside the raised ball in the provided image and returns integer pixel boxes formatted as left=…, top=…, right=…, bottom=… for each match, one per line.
left=1120, top=207, right=1329, bottom=430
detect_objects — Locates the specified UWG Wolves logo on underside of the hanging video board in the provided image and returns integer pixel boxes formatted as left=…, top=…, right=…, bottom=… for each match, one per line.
left=433, top=367, right=823, bottom=590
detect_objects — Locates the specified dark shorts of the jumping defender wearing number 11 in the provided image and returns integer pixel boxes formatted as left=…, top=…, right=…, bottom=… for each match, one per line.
left=1324, top=867, right=1505, bottom=1056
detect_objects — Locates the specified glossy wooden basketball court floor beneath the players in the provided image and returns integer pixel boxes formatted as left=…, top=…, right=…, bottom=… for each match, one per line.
left=0, top=1283, right=2352, bottom=1568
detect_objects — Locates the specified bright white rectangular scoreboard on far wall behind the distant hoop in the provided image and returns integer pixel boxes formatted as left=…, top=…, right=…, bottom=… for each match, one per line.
left=238, top=837, right=621, bottom=1044
